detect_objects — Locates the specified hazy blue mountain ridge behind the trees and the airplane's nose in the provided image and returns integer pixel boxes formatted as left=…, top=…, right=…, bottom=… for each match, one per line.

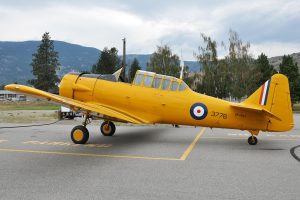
left=0, top=41, right=200, bottom=84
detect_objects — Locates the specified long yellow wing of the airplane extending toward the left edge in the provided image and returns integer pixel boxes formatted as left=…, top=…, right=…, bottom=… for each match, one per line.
left=5, top=84, right=149, bottom=124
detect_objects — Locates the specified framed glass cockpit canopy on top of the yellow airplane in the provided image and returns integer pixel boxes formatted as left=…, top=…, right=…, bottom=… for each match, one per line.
left=132, top=70, right=189, bottom=91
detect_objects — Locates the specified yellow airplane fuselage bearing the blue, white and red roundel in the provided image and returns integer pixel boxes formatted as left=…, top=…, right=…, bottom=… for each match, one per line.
left=60, top=74, right=269, bottom=131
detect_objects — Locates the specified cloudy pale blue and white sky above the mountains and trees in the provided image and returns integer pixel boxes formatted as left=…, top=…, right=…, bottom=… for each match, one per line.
left=0, top=0, right=300, bottom=60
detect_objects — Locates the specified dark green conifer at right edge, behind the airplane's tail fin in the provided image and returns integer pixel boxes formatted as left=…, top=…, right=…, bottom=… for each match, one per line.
left=279, top=55, right=300, bottom=104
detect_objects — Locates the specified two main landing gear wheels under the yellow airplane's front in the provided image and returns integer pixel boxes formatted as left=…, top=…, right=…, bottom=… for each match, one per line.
left=71, top=115, right=116, bottom=144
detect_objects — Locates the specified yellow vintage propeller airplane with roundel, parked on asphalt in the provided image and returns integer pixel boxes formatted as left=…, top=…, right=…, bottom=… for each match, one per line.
left=5, top=70, right=294, bottom=145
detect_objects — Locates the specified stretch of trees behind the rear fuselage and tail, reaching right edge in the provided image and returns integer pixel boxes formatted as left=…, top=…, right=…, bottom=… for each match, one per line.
left=193, top=30, right=300, bottom=103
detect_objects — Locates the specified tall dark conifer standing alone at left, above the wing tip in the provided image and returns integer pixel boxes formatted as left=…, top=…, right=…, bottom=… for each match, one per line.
left=28, top=32, right=60, bottom=92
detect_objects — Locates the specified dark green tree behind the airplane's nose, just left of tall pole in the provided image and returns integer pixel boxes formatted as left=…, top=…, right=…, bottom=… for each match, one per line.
left=92, top=47, right=120, bottom=74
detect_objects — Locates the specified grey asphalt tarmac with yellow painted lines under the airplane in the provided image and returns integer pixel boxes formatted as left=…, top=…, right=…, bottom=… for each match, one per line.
left=0, top=114, right=300, bottom=200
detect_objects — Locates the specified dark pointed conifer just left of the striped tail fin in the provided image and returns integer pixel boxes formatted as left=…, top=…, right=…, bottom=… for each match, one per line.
left=256, top=53, right=276, bottom=87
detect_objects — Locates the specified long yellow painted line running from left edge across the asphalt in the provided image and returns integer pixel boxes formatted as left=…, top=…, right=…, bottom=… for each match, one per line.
left=0, top=149, right=181, bottom=161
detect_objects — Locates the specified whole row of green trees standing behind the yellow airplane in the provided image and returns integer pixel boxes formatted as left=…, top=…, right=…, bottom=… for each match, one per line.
left=28, top=30, right=300, bottom=103
